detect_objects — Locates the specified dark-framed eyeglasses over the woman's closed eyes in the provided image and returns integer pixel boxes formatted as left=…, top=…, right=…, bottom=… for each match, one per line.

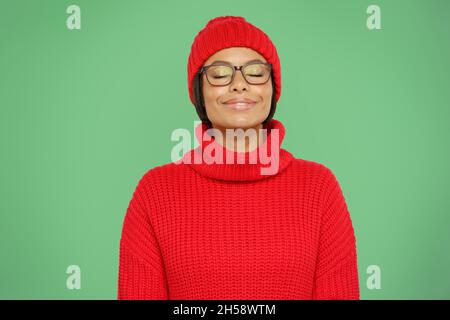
left=198, top=62, right=272, bottom=86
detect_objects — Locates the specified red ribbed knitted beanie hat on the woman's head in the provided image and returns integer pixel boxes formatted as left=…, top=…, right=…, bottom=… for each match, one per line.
left=188, top=16, right=281, bottom=105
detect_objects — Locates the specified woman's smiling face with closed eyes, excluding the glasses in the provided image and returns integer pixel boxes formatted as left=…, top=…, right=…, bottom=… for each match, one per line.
left=202, top=47, right=273, bottom=129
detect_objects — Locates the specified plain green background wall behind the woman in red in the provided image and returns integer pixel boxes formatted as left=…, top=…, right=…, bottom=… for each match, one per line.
left=0, top=0, right=450, bottom=299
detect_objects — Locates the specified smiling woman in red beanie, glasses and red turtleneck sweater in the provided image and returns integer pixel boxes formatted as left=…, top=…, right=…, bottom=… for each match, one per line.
left=118, top=16, right=359, bottom=300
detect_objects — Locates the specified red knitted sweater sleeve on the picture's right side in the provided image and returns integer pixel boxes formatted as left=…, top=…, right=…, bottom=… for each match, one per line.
left=313, top=168, right=359, bottom=300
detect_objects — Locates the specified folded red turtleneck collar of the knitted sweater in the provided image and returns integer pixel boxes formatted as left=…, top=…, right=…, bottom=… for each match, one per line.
left=181, top=119, right=294, bottom=181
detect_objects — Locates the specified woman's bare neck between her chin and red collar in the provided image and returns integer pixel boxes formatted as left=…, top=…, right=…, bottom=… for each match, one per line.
left=213, top=123, right=263, bottom=152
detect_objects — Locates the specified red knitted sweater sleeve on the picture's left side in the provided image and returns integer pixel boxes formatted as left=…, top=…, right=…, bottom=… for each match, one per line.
left=117, top=178, right=168, bottom=300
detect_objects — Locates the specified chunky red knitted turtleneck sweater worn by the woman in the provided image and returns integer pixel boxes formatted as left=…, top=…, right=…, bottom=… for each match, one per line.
left=118, top=119, right=359, bottom=300
